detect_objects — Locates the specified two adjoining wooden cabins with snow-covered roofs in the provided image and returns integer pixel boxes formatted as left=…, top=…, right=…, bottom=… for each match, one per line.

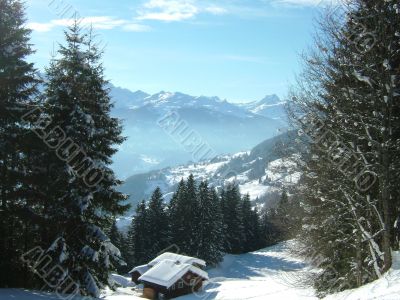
left=129, top=252, right=208, bottom=299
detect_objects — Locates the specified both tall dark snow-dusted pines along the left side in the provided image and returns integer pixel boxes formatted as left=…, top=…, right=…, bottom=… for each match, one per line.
left=0, top=0, right=128, bottom=297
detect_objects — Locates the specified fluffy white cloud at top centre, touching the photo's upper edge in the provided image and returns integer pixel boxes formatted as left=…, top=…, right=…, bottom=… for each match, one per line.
left=137, top=0, right=227, bottom=22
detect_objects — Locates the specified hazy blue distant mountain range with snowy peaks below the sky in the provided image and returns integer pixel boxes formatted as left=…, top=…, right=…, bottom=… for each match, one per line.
left=110, top=86, right=287, bottom=178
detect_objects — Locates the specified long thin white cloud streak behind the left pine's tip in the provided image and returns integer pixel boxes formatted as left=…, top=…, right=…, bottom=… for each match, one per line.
left=27, top=16, right=150, bottom=32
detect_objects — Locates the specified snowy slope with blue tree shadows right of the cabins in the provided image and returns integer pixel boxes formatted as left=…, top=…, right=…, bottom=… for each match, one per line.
left=178, top=242, right=317, bottom=300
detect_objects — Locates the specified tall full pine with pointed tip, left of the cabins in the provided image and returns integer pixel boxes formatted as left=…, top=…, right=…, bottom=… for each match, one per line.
left=40, top=22, right=128, bottom=297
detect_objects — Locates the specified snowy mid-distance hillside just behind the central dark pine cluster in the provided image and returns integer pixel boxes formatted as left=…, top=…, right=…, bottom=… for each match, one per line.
left=119, top=132, right=299, bottom=216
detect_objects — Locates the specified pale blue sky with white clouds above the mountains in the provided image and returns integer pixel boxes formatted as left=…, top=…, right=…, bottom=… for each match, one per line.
left=26, top=0, right=332, bottom=102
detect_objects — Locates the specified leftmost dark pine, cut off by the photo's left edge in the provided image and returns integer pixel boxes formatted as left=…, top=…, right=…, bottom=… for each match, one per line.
left=0, top=0, right=42, bottom=286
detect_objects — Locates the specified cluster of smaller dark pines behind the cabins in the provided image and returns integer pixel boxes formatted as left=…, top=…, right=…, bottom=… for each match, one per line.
left=110, top=175, right=295, bottom=272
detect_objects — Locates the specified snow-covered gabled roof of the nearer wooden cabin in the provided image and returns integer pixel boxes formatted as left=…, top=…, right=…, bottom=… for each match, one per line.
left=139, top=259, right=208, bottom=289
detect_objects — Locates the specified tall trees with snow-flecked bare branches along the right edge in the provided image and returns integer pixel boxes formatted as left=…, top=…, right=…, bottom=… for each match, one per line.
left=289, top=0, right=400, bottom=296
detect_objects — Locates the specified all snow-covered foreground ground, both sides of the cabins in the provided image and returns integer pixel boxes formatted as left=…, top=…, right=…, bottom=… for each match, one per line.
left=0, top=241, right=400, bottom=300
